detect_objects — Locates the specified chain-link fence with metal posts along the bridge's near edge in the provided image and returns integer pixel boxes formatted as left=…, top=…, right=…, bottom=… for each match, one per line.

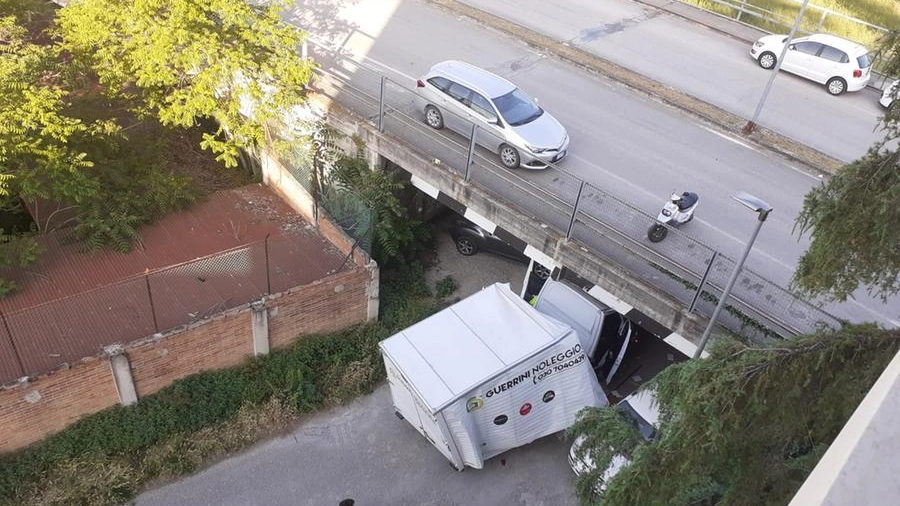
left=315, top=40, right=841, bottom=336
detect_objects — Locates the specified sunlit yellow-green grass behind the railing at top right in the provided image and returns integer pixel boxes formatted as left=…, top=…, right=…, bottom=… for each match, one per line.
left=681, top=0, right=900, bottom=50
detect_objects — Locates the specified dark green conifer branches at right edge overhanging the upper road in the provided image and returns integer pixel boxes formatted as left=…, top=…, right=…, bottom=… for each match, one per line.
left=793, top=32, right=900, bottom=300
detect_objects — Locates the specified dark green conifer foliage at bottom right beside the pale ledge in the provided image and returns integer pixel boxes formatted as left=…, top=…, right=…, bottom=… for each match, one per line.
left=570, top=326, right=900, bottom=506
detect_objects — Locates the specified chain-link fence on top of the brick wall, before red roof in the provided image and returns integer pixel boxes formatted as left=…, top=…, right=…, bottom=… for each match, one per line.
left=0, top=235, right=352, bottom=383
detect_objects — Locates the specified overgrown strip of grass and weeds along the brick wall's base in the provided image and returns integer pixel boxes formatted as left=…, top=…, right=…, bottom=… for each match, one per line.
left=0, top=263, right=445, bottom=506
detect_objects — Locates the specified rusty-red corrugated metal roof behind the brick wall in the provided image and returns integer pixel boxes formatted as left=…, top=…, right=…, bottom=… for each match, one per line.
left=0, top=185, right=353, bottom=383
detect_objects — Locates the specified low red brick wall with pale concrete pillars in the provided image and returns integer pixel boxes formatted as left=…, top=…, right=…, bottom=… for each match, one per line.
left=0, top=264, right=370, bottom=453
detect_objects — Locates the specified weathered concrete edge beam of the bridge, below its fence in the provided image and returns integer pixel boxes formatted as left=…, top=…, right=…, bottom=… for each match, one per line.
left=328, top=104, right=708, bottom=340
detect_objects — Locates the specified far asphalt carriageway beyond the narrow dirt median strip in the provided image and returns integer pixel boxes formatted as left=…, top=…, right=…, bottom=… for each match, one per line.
left=460, top=0, right=883, bottom=162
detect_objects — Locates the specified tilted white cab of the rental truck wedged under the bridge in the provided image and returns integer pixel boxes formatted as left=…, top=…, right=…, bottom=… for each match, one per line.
left=534, top=279, right=632, bottom=385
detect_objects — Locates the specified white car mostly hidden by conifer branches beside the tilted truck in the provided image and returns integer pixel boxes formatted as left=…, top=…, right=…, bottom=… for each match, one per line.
left=569, top=390, right=659, bottom=495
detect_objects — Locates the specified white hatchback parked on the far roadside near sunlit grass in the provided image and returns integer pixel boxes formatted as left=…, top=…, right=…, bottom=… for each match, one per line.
left=750, top=34, right=872, bottom=95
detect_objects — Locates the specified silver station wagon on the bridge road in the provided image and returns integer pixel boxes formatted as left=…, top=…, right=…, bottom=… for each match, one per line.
left=416, top=60, right=569, bottom=169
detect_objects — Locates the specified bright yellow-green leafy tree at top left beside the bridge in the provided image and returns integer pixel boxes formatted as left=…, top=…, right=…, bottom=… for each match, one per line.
left=58, top=0, right=313, bottom=166
